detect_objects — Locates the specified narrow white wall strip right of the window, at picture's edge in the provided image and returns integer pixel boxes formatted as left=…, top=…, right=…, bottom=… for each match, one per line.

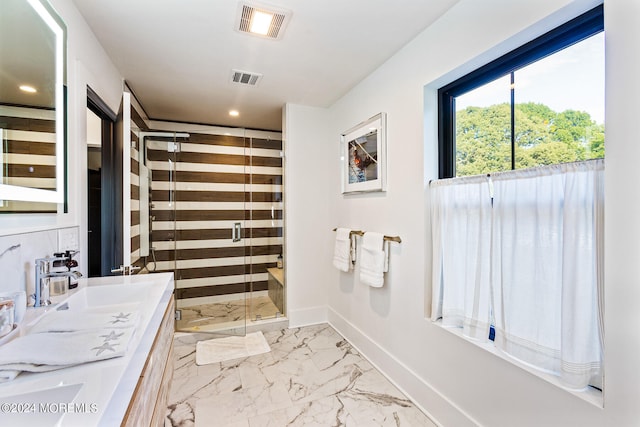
left=605, top=0, right=640, bottom=426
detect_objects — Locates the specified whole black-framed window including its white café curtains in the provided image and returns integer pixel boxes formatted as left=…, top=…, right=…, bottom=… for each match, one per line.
left=430, top=6, right=604, bottom=390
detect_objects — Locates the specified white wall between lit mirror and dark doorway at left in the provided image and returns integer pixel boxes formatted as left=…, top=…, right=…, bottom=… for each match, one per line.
left=0, top=0, right=122, bottom=273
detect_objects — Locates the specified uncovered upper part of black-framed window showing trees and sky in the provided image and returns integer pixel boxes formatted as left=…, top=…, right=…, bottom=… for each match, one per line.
left=438, top=6, right=604, bottom=178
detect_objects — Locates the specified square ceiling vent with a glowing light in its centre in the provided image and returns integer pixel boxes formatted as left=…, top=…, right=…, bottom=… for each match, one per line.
left=236, top=2, right=291, bottom=39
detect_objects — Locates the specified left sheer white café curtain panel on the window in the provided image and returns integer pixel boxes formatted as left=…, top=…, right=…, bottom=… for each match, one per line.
left=431, top=177, right=491, bottom=340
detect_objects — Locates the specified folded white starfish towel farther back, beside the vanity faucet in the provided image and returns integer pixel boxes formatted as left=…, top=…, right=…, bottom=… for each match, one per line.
left=29, top=310, right=139, bottom=333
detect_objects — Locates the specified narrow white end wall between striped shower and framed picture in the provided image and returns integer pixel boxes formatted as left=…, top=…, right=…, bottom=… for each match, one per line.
left=282, top=105, right=338, bottom=326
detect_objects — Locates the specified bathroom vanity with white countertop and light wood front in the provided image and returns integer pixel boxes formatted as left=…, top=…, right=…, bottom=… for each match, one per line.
left=0, top=273, right=175, bottom=426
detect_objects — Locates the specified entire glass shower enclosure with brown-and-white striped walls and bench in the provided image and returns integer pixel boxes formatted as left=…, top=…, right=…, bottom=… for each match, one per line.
left=132, top=125, right=285, bottom=335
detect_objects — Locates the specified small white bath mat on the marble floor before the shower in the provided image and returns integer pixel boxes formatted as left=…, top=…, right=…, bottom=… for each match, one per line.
left=196, top=331, right=271, bottom=365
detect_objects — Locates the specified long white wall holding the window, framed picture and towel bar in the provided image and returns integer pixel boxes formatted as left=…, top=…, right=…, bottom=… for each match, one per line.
left=287, top=0, right=640, bottom=427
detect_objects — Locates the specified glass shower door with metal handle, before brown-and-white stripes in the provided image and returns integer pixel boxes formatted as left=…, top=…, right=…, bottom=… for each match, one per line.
left=148, top=131, right=251, bottom=335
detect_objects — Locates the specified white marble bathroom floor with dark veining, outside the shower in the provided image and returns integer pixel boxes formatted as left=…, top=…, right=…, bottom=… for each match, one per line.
left=165, top=324, right=435, bottom=427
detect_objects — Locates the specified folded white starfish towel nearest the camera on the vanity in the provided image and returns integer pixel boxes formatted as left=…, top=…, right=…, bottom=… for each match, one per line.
left=0, top=328, right=135, bottom=383
